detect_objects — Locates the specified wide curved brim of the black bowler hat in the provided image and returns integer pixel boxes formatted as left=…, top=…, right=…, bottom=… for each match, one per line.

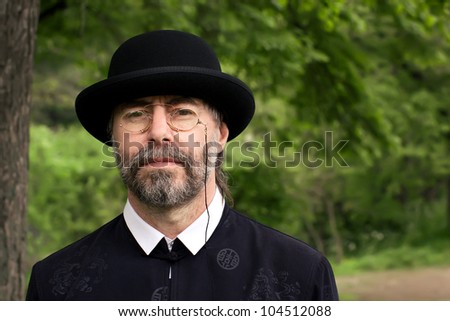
left=75, top=67, right=255, bottom=145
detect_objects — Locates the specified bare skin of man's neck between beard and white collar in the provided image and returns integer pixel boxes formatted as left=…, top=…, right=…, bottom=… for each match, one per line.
left=128, top=179, right=216, bottom=239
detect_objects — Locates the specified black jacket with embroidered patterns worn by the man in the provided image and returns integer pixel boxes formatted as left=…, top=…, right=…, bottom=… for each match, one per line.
left=27, top=206, right=338, bottom=301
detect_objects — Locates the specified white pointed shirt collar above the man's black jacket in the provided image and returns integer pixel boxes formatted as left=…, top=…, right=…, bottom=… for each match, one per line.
left=123, top=188, right=225, bottom=255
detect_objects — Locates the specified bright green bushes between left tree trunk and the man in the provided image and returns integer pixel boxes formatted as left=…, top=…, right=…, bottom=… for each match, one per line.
left=28, top=126, right=126, bottom=260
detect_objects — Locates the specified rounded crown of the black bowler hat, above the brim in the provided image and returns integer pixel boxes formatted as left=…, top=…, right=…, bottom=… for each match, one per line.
left=108, top=30, right=221, bottom=78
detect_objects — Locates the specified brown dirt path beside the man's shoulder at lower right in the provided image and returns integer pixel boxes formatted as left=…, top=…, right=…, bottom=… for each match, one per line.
left=336, top=266, right=450, bottom=301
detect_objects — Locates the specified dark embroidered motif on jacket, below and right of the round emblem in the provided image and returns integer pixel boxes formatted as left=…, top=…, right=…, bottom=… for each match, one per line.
left=249, top=268, right=301, bottom=300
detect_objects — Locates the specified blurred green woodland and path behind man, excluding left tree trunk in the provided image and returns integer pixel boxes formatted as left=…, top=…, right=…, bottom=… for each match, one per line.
left=27, top=0, right=450, bottom=300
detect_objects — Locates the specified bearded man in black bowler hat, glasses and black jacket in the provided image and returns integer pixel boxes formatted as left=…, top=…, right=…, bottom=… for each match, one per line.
left=27, top=30, right=338, bottom=300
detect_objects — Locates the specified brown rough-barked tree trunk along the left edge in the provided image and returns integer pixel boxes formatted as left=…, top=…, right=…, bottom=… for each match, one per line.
left=0, top=0, right=39, bottom=300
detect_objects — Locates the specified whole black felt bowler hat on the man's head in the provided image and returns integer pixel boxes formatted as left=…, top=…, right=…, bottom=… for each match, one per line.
left=75, top=30, right=255, bottom=143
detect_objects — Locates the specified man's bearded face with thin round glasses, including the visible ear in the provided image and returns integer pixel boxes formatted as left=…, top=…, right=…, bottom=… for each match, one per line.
left=113, top=96, right=228, bottom=208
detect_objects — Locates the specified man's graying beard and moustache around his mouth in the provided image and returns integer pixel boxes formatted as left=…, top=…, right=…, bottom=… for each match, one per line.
left=116, top=145, right=210, bottom=209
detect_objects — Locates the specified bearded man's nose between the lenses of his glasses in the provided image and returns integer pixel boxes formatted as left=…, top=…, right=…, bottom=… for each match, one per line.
left=147, top=105, right=173, bottom=145
